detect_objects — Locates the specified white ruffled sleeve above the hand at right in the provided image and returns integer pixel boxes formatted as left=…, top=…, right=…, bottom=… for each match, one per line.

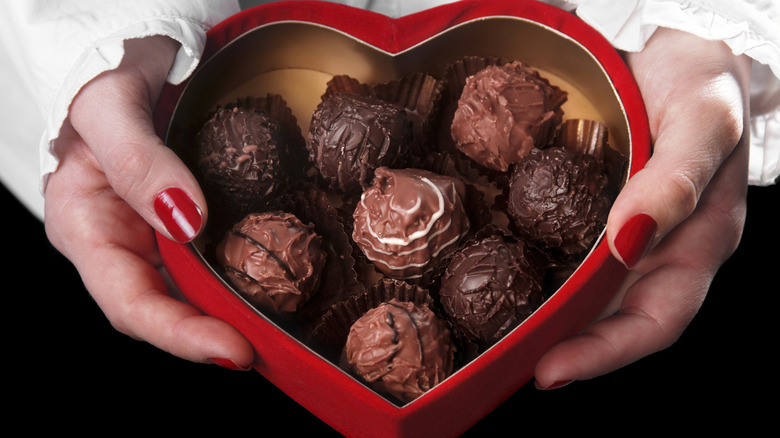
left=558, top=0, right=780, bottom=185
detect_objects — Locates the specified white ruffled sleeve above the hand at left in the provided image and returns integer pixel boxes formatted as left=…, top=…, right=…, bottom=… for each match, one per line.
left=0, top=0, right=239, bottom=210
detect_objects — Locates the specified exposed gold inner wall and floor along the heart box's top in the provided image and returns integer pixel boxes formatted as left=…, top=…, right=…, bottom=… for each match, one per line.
left=167, top=17, right=630, bottom=163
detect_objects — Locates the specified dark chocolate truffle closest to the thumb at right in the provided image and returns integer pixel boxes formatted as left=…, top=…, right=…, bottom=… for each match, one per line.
left=506, top=147, right=611, bottom=256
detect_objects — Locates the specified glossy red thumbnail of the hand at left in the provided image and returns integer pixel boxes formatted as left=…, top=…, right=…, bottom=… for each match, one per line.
left=154, top=187, right=203, bottom=243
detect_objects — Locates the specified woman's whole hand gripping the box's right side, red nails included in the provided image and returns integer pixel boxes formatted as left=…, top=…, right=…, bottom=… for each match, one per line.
left=536, top=29, right=750, bottom=389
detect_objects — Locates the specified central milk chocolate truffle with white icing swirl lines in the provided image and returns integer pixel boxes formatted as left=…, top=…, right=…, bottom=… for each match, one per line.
left=352, top=167, right=469, bottom=279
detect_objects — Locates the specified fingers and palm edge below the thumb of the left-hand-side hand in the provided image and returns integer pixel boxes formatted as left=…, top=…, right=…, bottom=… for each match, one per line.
left=45, top=123, right=254, bottom=369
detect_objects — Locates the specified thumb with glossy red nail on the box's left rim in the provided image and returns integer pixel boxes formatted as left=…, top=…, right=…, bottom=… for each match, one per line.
left=70, top=37, right=206, bottom=242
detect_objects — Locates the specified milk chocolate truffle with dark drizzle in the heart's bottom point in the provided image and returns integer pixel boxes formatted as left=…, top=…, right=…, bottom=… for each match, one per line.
left=345, top=299, right=455, bottom=402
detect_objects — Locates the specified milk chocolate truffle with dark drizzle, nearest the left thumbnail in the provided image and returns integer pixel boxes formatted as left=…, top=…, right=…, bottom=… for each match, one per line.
left=216, top=212, right=326, bottom=315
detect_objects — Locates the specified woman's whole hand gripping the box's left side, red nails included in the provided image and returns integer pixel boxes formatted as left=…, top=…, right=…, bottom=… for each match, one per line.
left=45, top=36, right=254, bottom=369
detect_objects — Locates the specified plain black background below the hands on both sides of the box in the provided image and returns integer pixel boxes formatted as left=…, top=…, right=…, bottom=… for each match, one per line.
left=2, top=181, right=780, bottom=436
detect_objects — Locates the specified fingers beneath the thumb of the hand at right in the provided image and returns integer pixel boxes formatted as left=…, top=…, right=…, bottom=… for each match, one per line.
left=536, top=110, right=748, bottom=388
